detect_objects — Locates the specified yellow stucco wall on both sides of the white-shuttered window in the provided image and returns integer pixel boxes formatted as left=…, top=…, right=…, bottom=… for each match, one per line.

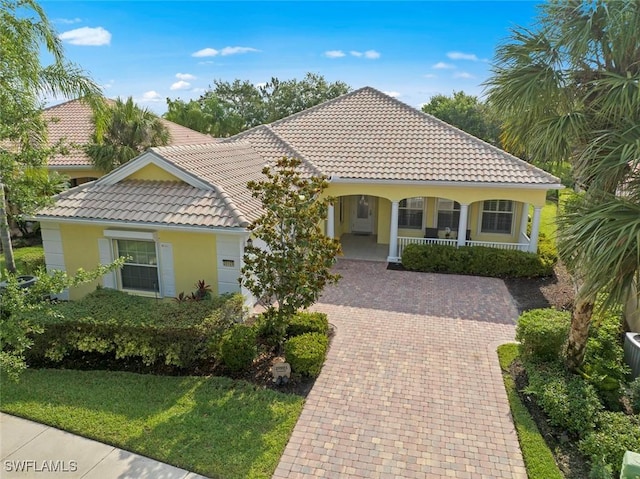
left=60, top=224, right=218, bottom=299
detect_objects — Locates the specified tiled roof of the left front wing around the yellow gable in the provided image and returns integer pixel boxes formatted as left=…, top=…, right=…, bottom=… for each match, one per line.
left=37, top=142, right=265, bottom=228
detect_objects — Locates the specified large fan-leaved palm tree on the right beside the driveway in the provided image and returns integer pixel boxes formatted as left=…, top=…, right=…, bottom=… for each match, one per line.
left=486, top=0, right=640, bottom=370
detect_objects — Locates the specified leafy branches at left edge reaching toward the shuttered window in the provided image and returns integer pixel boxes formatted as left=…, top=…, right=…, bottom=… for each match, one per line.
left=0, top=258, right=124, bottom=379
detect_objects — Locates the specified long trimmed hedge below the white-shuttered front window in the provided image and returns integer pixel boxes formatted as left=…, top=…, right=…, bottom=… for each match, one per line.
left=29, top=289, right=243, bottom=367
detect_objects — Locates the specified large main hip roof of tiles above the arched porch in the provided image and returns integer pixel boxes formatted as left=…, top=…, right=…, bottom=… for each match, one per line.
left=230, top=87, right=560, bottom=186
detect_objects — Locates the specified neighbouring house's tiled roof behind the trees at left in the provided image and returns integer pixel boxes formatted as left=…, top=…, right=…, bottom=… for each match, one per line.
left=44, top=100, right=219, bottom=169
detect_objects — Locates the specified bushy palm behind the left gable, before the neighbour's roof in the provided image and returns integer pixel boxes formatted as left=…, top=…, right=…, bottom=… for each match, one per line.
left=87, top=97, right=169, bottom=172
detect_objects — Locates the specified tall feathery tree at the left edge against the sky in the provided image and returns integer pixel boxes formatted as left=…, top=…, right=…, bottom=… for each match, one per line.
left=0, top=0, right=100, bottom=271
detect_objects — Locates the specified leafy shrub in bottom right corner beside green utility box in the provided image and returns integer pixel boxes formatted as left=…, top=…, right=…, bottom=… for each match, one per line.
left=579, top=411, right=640, bottom=477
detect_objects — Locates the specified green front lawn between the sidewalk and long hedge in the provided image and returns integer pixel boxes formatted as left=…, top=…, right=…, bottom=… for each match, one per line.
left=0, top=369, right=303, bottom=478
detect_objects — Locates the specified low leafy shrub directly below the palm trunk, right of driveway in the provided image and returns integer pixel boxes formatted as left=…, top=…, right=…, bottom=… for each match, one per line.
left=525, top=363, right=602, bottom=438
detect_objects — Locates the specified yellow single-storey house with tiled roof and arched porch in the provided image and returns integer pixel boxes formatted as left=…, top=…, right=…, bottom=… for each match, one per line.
left=36, top=87, right=561, bottom=299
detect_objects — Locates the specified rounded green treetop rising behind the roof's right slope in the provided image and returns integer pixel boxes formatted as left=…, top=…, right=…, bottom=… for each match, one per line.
left=422, top=91, right=500, bottom=147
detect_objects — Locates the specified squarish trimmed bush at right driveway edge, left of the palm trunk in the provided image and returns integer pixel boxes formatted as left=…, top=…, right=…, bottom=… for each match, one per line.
left=516, top=308, right=571, bottom=361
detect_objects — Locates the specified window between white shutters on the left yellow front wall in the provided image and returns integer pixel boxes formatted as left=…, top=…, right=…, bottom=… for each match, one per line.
left=116, top=240, right=160, bottom=292
